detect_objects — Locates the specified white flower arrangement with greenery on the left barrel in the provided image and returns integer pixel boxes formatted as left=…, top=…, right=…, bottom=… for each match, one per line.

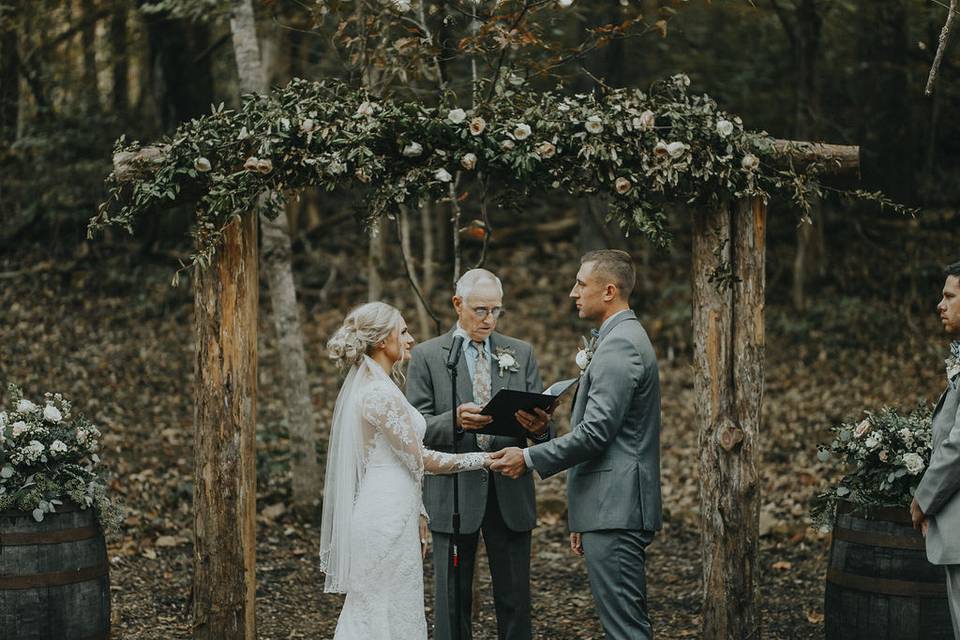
left=0, top=385, right=121, bottom=529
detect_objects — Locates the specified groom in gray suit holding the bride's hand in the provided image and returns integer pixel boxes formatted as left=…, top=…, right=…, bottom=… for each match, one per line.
left=491, top=250, right=661, bottom=640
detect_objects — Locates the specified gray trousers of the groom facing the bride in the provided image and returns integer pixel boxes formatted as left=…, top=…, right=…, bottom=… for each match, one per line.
left=582, top=529, right=654, bottom=640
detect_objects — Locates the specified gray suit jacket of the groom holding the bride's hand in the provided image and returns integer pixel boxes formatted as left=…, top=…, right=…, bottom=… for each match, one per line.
left=530, top=311, right=662, bottom=533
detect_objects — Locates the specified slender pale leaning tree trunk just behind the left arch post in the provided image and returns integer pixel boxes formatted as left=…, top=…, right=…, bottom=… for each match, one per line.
left=230, top=0, right=320, bottom=513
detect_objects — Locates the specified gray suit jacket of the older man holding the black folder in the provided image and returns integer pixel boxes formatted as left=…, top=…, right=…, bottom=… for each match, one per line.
left=406, top=330, right=543, bottom=533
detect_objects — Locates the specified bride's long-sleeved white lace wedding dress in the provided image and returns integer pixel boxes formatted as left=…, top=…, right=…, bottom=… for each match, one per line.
left=321, top=358, right=486, bottom=640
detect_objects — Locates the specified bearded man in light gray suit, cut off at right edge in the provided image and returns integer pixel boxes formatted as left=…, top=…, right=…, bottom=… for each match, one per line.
left=910, top=262, right=960, bottom=640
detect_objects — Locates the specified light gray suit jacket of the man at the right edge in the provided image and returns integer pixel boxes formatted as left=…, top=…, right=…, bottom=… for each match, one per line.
left=914, top=380, right=960, bottom=564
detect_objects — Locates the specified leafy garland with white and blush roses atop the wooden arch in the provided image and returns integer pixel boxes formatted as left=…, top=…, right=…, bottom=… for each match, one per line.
left=89, top=75, right=912, bottom=266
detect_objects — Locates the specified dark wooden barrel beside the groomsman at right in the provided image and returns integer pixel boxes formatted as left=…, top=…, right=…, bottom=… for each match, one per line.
left=823, top=503, right=953, bottom=640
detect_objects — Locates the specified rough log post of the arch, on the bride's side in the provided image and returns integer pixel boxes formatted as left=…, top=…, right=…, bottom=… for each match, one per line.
left=193, top=215, right=259, bottom=640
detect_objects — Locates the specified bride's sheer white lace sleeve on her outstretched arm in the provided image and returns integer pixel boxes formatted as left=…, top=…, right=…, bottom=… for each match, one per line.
left=362, top=389, right=487, bottom=481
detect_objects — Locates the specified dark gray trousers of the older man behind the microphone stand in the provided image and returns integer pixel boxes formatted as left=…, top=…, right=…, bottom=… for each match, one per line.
left=432, top=482, right=533, bottom=640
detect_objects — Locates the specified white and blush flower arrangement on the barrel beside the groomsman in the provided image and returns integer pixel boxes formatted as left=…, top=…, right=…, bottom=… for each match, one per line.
left=811, top=404, right=932, bottom=532
